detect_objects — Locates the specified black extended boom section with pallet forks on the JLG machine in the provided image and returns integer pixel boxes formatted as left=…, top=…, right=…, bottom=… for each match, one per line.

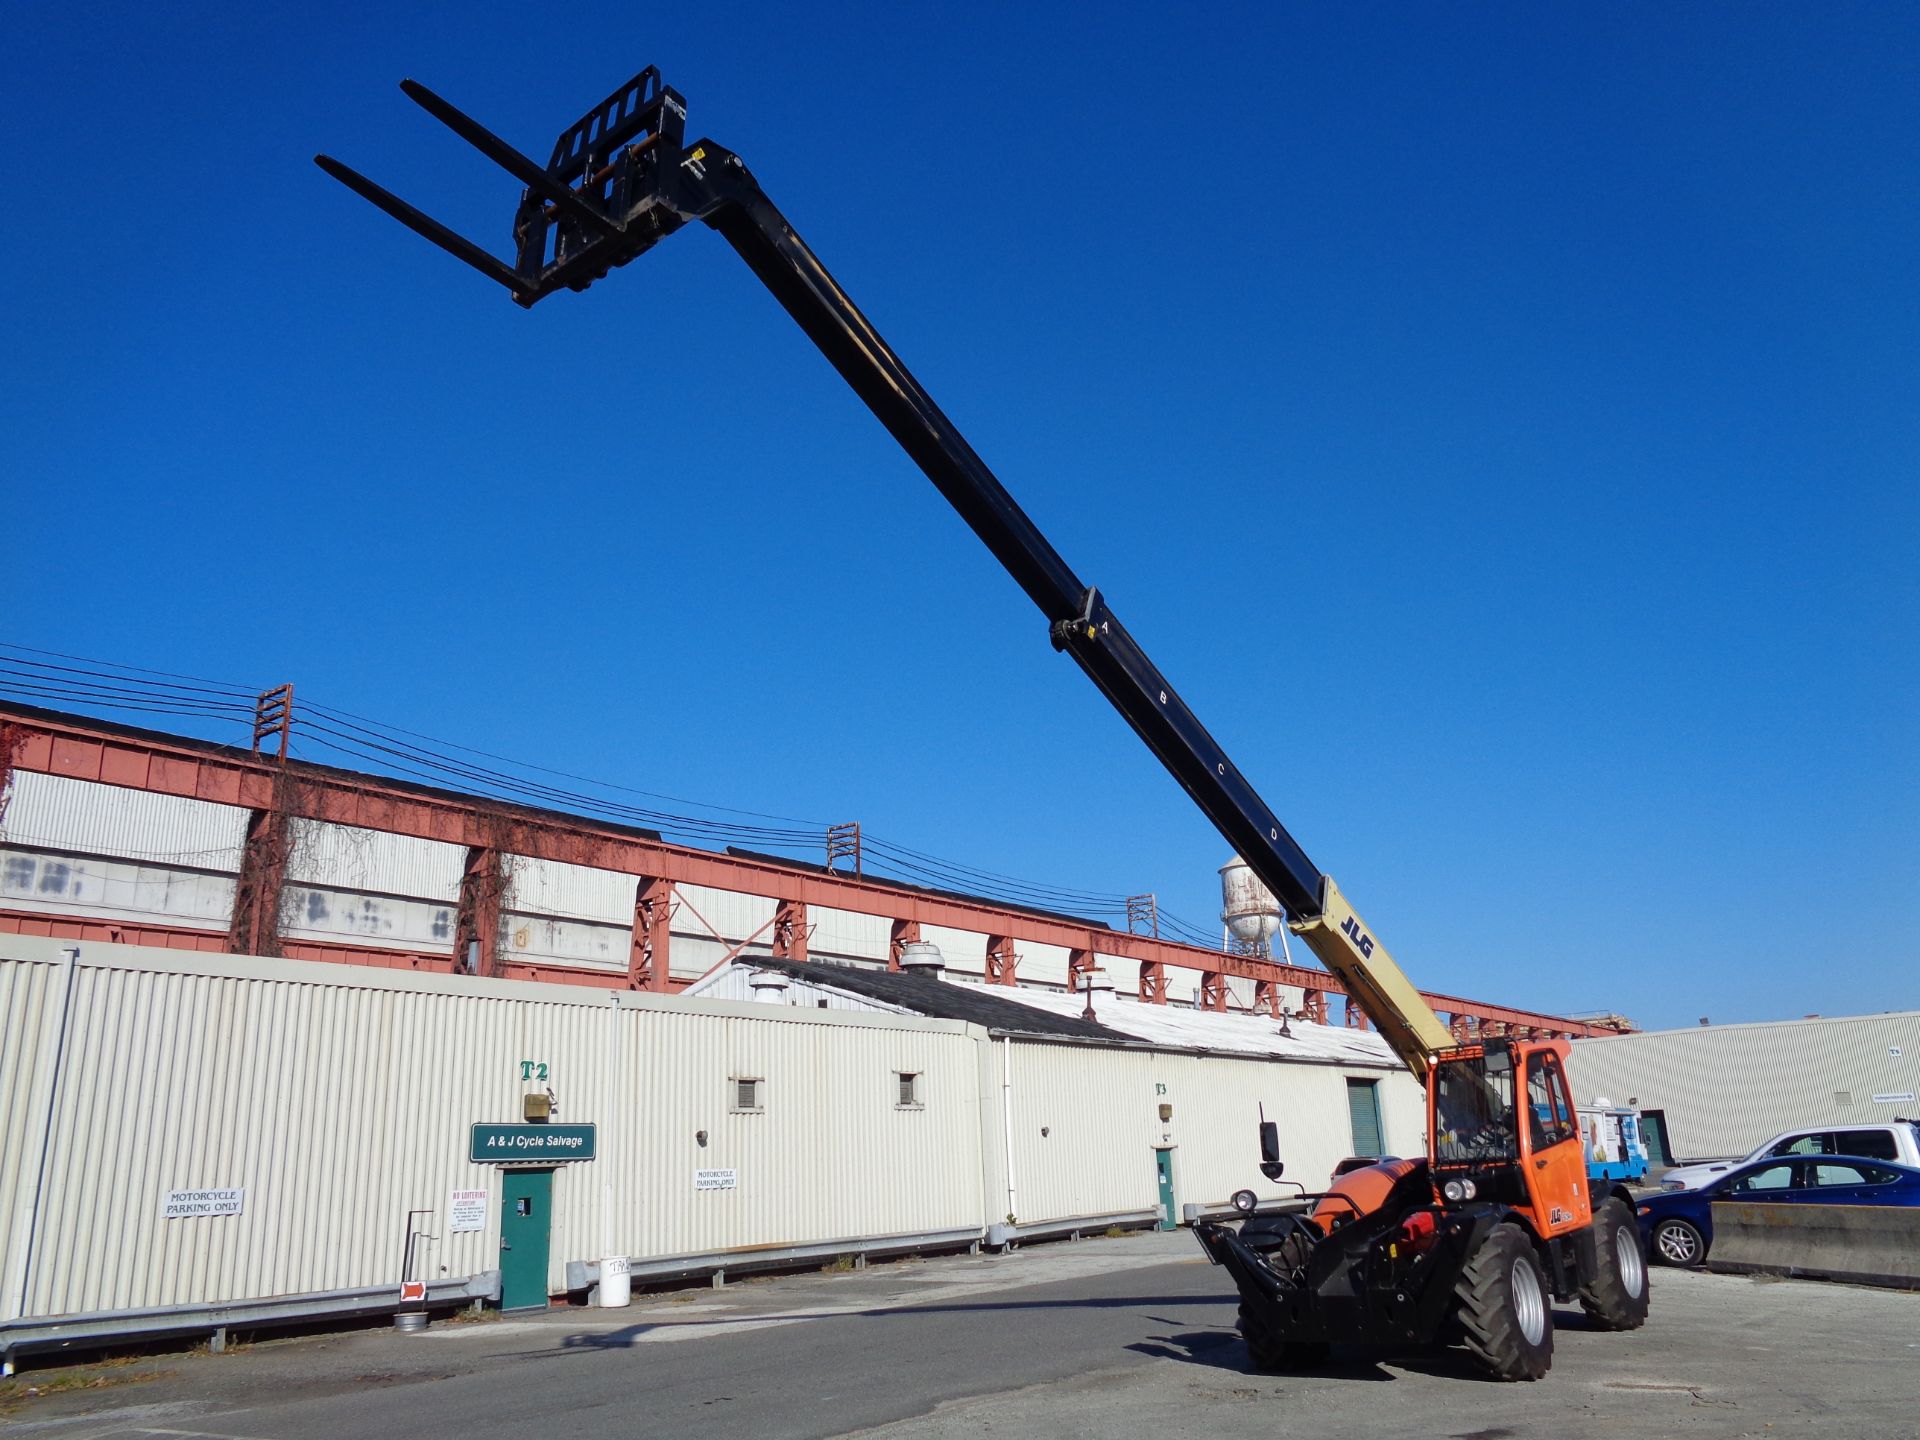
left=315, top=67, right=1321, bottom=918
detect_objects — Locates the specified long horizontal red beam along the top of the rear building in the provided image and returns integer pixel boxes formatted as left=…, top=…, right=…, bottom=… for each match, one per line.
left=0, top=707, right=1611, bottom=1035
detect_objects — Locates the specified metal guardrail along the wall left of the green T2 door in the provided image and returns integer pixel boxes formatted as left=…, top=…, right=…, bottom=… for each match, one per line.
left=0, top=1269, right=499, bottom=1375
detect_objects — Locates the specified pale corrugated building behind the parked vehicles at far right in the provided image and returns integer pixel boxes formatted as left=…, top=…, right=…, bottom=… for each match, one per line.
left=1569, top=1010, right=1920, bottom=1160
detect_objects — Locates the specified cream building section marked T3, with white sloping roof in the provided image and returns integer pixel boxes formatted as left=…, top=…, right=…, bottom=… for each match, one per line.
left=687, top=960, right=1427, bottom=1221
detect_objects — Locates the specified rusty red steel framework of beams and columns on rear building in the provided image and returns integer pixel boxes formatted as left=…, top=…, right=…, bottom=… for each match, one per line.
left=0, top=706, right=1613, bottom=1037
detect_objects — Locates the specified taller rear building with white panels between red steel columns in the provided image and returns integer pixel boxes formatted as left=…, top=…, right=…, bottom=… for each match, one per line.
left=0, top=705, right=1612, bottom=1035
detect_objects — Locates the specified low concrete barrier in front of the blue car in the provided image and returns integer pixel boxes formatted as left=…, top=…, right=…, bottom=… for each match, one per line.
left=1707, top=1200, right=1920, bottom=1290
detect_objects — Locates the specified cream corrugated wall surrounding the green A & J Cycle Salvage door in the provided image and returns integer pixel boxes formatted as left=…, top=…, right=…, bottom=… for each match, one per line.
left=0, top=937, right=981, bottom=1315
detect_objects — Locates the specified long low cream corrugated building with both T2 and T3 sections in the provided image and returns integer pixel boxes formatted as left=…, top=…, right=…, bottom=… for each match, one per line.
left=0, top=935, right=1423, bottom=1350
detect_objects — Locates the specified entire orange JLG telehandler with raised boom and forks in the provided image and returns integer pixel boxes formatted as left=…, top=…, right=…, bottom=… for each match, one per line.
left=315, top=67, right=1647, bottom=1380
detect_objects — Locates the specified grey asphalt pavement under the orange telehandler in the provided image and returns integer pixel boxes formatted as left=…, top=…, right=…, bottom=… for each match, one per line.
left=0, top=1235, right=1920, bottom=1440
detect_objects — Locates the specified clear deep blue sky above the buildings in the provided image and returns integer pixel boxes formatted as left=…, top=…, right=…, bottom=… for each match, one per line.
left=0, top=4, right=1920, bottom=1025
